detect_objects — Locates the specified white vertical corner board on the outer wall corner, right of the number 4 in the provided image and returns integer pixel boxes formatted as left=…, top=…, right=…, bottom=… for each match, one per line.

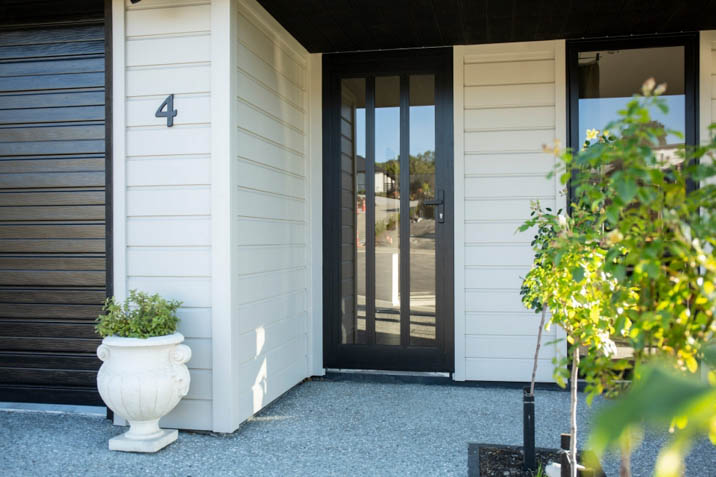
left=211, top=0, right=240, bottom=432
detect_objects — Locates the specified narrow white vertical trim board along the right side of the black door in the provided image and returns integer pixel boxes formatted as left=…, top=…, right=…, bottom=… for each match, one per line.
left=453, top=46, right=466, bottom=381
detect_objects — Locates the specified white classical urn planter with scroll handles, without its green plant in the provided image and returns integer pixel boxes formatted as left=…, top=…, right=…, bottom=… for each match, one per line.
left=97, top=333, right=191, bottom=452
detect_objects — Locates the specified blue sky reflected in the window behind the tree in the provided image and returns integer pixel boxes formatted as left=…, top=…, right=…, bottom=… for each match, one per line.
left=578, top=94, right=686, bottom=147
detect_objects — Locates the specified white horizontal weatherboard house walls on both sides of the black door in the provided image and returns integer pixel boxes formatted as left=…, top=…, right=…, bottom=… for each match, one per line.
left=113, top=0, right=716, bottom=432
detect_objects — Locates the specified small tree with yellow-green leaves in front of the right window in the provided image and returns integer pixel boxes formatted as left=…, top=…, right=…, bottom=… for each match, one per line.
left=523, top=80, right=716, bottom=475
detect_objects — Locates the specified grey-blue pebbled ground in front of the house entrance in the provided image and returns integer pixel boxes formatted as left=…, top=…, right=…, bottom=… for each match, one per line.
left=0, top=381, right=716, bottom=476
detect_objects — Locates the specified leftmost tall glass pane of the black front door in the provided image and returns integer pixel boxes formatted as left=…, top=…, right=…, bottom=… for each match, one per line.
left=340, top=78, right=366, bottom=344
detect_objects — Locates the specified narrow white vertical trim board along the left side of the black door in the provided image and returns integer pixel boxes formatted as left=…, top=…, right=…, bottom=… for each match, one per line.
left=307, top=53, right=326, bottom=376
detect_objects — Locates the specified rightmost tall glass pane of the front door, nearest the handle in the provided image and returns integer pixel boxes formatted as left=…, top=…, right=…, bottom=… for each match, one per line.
left=410, top=75, right=437, bottom=346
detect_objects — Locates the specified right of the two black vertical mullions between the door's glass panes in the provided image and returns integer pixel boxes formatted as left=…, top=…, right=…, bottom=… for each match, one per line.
left=400, top=74, right=410, bottom=346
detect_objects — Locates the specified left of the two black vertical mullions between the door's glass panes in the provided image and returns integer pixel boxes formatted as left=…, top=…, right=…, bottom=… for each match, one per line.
left=365, top=76, right=375, bottom=345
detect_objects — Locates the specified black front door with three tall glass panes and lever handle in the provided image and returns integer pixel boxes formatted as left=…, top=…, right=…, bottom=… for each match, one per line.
left=323, top=48, right=453, bottom=372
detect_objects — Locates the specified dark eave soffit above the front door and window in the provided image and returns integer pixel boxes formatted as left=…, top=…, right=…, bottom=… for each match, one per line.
left=258, top=0, right=716, bottom=53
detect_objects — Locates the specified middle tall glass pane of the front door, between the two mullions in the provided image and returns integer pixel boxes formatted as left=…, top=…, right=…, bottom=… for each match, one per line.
left=375, top=76, right=400, bottom=345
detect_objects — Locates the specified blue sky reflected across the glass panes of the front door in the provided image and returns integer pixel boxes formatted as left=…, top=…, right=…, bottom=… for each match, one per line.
left=356, top=106, right=435, bottom=157
